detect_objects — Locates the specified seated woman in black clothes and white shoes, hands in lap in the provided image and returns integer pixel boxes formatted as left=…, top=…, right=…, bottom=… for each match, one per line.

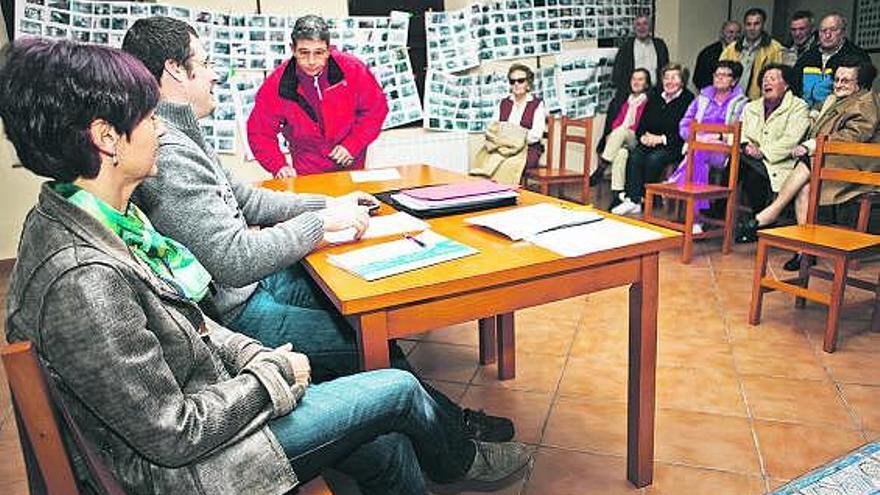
left=611, top=63, right=694, bottom=215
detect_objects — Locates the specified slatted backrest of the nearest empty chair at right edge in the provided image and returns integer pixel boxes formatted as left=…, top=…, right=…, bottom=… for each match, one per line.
left=807, top=135, right=880, bottom=223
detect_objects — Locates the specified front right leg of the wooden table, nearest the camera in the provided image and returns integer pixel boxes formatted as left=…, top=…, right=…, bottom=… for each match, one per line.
left=626, top=253, right=659, bottom=487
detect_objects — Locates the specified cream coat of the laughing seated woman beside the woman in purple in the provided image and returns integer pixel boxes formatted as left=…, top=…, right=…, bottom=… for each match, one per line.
left=742, top=91, right=810, bottom=192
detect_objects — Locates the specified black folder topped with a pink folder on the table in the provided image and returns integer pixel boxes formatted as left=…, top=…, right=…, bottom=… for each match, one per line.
left=391, top=180, right=518, bottom=212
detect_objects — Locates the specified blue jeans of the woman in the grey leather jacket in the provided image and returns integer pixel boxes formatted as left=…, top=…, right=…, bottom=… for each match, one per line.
left=269, top=369, right=475, bottom=495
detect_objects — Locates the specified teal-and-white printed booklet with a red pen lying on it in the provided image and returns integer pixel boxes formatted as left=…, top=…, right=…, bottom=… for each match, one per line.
left=327, top=230, right=478, bottom=281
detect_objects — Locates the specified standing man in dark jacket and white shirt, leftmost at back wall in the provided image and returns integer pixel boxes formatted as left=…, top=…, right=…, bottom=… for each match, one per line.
left=611, top=14, right=669, bottom=93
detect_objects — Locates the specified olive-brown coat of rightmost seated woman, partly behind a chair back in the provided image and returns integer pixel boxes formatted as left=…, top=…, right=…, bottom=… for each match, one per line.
left=804, top=90, right=880, bottom=205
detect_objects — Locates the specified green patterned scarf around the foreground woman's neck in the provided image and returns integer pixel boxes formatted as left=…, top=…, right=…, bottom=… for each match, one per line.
left=51, top=182, right=211, bottom=302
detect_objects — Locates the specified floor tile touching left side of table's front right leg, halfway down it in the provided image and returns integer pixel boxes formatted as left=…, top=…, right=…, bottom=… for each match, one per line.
left=559, top=357, right=627, bottom=403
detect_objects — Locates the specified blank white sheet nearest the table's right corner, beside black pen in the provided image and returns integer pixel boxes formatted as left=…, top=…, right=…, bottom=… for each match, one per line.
left=529, top=218, right=662, bottom=257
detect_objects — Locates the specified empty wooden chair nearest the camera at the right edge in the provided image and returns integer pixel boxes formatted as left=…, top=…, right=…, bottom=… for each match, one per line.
left=749, top=136, right=880, bottom=352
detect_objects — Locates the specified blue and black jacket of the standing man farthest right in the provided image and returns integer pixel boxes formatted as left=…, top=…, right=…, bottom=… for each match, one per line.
left=792, top=39, right=871, bottom=109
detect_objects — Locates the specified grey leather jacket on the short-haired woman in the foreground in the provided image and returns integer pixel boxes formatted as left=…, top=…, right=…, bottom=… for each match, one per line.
left=6, top=185, right=296, bottom=494
